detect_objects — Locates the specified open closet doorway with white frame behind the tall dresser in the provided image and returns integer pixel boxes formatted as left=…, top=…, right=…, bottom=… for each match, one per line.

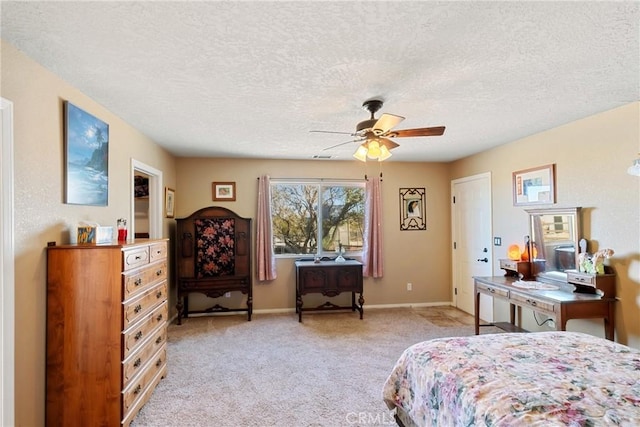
left=129, top=159, right=164, bottom=239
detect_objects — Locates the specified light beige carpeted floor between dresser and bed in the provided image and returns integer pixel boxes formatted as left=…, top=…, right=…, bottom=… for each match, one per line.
left=132, top=307, right=498, bottom=427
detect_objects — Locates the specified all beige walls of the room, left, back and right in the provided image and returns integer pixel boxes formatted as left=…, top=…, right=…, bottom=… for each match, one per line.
left=1, top=35, right=640, bottom=426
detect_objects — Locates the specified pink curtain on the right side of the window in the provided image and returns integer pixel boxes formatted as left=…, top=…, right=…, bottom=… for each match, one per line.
left=362, top=177, right=383, bottom=277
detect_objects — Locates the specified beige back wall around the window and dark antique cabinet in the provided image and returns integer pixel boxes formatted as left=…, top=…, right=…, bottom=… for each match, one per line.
left=176, top=158, right=451, bottom=310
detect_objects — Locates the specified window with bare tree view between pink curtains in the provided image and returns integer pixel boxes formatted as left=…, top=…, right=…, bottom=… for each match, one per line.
left=271, top=180, right=365, bottom=256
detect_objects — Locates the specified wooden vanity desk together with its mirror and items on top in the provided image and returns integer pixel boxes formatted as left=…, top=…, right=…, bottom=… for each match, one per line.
left=474, top=207, right=616, bottom=341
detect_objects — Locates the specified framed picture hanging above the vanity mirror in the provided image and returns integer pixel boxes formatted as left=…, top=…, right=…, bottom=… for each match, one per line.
left=513, top=164, right=556, bottom=206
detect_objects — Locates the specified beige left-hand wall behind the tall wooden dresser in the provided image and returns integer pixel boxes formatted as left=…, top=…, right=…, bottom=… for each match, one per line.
left=1, top=42, right=175, bottom=426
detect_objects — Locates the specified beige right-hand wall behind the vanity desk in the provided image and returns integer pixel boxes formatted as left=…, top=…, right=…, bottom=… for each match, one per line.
left=451, top=102, right=640, bottom=348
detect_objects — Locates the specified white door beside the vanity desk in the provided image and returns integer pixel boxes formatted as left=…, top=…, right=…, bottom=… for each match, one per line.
left=451, top=173, right=493, bottom=322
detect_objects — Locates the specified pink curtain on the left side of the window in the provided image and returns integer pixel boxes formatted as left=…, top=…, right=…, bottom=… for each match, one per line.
left=256, top=175, right=277, bottom=282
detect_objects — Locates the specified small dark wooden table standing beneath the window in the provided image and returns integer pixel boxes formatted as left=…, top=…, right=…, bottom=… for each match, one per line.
left=295, top=260, right=364, bottom=322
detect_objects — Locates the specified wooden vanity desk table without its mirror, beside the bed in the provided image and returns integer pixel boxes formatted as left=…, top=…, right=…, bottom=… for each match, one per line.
left=474, top=274, right=616, bottom=341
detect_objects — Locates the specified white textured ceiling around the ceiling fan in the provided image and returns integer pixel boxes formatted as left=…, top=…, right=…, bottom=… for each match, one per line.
left=0, top=1, right=640, bottom=161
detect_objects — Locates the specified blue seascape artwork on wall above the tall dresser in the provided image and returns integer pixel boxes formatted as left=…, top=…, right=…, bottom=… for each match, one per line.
left=64, top=101, right=109, bottom=206
